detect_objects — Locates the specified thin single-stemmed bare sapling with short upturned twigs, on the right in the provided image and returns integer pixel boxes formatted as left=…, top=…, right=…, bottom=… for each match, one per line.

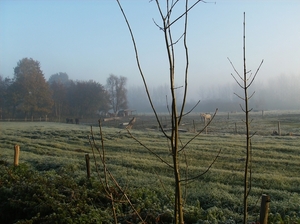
left=228, top=13, right=263, bottom=224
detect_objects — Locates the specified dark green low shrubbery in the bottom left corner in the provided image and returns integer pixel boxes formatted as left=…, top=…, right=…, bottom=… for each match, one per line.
left=0, top=164, right=111, bottom=223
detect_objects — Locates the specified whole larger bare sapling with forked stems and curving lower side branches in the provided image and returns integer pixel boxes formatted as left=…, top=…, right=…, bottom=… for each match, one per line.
left=117, top=0, right=220, bottom=223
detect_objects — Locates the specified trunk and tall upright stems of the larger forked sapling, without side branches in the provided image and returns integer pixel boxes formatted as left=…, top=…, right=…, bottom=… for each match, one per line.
left=117, top=0, right=209, bottom=224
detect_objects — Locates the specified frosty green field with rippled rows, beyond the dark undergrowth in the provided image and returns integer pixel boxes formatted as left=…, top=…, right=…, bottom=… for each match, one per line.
left=0, top=111, right=300, bottom=223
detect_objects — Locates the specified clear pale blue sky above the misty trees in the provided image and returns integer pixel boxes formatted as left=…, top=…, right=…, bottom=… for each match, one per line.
left=0, top=0, right=300, bottom=93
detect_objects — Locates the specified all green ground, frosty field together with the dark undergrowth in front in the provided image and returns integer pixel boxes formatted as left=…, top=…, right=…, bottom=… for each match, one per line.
left=0, top=111, right=300, bottom=223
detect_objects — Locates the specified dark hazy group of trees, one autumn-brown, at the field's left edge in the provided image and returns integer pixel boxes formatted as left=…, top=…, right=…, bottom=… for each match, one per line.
left=0, top=58, right=128, bottom=120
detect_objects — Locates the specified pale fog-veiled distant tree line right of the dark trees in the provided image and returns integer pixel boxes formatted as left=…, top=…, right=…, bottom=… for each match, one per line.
left=128, top=74, right=300, bottom=112
